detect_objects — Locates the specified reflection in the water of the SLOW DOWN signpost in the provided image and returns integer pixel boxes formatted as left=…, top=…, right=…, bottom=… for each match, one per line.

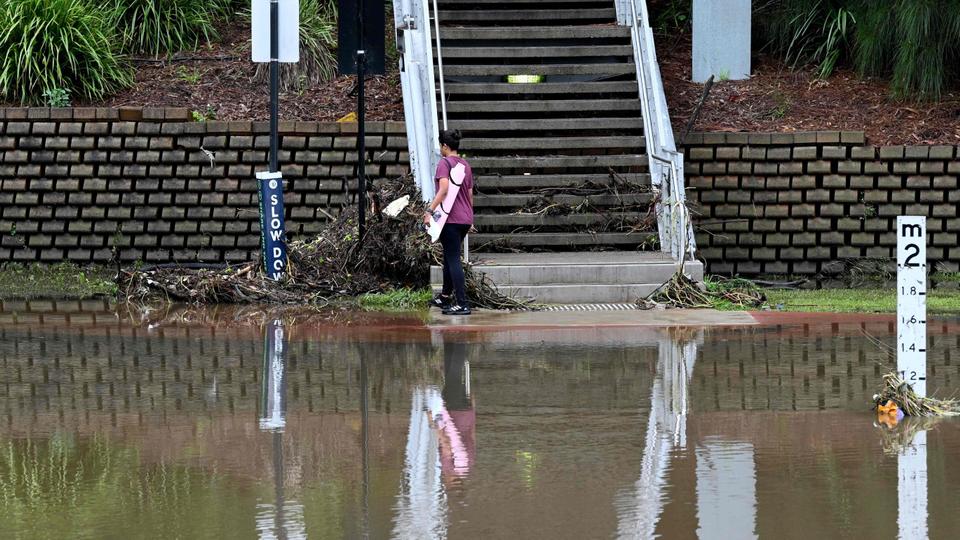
left=256, top=320, right=307, bottom=540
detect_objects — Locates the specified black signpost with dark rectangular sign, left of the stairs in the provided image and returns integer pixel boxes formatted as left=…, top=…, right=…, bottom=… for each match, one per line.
left=337, top=0, right=385, bottom=246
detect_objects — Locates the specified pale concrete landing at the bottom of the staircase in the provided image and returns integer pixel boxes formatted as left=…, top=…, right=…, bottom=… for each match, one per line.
left=431, top=251, right=703, bottom=304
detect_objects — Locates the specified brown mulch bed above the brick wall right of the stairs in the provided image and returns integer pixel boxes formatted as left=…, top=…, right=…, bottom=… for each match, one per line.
left=657, top=35, right=960, bottom=145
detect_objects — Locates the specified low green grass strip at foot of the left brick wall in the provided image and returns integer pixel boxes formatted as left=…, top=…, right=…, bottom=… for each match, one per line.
left=0, top=263, right=117, bottom=300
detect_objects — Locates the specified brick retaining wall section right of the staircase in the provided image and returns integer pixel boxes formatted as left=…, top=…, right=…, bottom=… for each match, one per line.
left=685, top=131, right=960, bottom=276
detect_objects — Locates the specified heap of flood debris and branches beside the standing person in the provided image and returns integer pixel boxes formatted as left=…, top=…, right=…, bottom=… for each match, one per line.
left=118, top=178, right=525, bottom=309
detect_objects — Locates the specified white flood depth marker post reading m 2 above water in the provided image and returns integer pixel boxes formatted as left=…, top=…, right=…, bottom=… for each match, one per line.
left=897, top=216, right=927, bottom=397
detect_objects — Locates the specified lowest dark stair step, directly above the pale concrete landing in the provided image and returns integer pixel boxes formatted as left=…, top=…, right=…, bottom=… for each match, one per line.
left=470, top=233, right=655, bottom=252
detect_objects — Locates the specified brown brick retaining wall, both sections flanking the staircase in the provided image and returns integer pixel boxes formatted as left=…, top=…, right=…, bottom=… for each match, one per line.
left=0, top=108, right=960, bottom=275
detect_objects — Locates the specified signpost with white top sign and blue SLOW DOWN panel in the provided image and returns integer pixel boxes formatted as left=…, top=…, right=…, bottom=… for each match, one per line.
left=250, top=0, right=300, bottom=280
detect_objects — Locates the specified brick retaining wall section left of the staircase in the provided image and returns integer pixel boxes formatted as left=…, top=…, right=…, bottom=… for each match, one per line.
left=0, top=108, right=409, bottom=262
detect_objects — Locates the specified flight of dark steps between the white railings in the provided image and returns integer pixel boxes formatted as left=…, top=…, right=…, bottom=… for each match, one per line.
left=438, top=0, right=657, bottom=251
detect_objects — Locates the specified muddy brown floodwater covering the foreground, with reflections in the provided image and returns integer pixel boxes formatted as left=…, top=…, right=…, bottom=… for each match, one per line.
left=0, top=303, right=960, bottom=539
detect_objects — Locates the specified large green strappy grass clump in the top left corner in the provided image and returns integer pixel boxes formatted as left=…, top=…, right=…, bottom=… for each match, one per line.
left=0, top=0, right=133, bottom=105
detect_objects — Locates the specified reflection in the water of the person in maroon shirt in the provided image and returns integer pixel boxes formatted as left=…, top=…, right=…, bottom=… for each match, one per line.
left=438, top=341, right=477, bottom=477
